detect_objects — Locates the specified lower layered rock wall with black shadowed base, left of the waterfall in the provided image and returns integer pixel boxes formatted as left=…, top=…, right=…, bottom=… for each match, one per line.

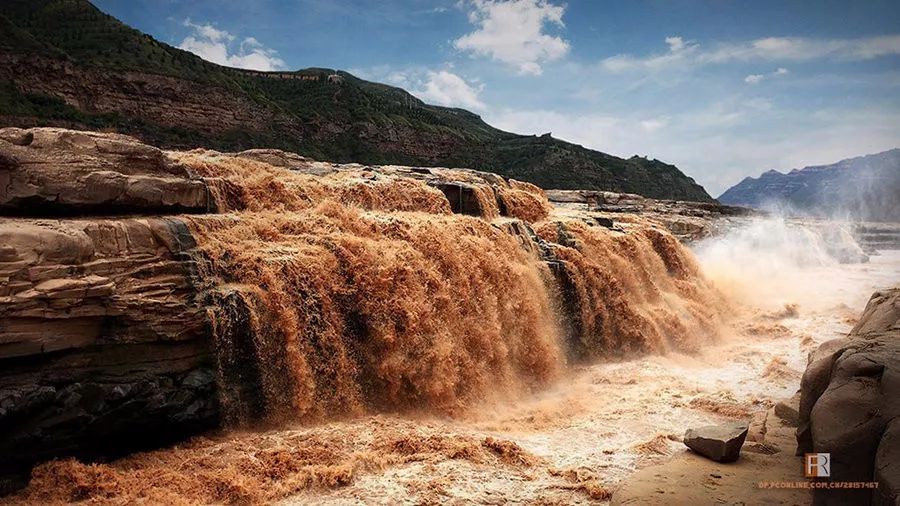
left=0, top=218, right=218, bottom=471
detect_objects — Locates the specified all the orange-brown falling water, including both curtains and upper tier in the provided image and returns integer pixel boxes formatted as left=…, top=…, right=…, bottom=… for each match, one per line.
left=167, top=151, right=722, bottom=423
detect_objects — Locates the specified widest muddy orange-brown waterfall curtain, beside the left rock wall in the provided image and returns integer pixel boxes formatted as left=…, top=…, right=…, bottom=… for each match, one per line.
left=191, top=203, right=562, bottom=417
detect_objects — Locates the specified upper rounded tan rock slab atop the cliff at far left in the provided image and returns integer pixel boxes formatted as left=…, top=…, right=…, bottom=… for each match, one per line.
left=0, top=128, right=212, bottom=216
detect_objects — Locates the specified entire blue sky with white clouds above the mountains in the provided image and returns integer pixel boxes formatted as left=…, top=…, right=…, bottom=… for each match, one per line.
left=93, top=0, right=900, bottom=196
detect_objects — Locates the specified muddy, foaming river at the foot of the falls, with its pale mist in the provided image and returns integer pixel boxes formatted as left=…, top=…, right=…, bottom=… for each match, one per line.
left=8, top=219, right=900, bottom=504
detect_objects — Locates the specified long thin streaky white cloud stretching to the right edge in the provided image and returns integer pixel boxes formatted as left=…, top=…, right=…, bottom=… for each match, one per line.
left=601, top=35, right=900, bottom=74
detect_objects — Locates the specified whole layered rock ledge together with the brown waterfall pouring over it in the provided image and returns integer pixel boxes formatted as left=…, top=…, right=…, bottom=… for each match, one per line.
left=0, top=128, right=727, bottom=478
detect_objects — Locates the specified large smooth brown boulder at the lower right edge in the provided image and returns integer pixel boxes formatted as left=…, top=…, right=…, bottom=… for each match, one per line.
left=797, top=288, right=900, bottom=504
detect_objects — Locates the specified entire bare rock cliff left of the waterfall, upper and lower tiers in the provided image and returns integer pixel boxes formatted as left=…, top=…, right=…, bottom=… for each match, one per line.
left=0, top=129, right=218, bottom=470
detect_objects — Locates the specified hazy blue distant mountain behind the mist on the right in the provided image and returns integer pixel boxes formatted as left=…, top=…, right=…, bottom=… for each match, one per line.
left=719, top=149, right=900, bottom=221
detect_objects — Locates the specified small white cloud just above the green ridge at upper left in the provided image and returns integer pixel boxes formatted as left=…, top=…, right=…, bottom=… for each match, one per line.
left=178, top=19, right=285, bottom=71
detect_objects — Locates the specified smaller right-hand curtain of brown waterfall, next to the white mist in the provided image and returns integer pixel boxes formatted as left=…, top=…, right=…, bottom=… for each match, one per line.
left=538, top=220, right=727, bottom=360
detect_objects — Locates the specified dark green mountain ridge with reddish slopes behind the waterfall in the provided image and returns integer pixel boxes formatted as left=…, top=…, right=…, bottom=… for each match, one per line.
left=0, top=0, right=713, bottom=201
